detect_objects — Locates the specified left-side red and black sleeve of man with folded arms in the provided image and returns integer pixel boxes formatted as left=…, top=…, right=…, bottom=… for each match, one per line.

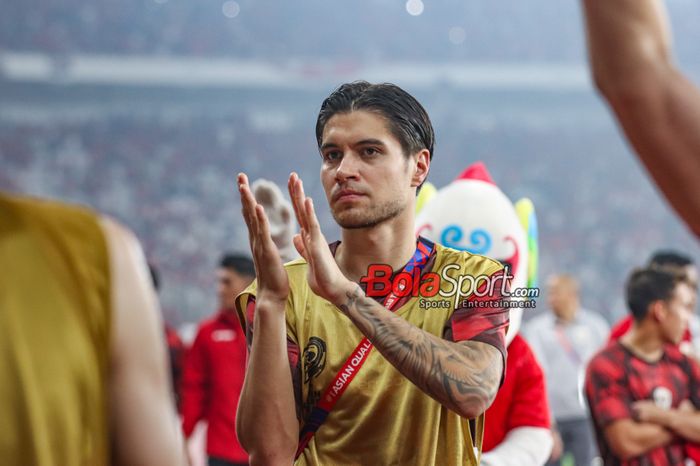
left=586, top=353, right=632, bottom=429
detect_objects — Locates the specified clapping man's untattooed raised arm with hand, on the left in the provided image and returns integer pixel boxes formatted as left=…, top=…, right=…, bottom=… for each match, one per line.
left=236, top=175, right=299, bottom=465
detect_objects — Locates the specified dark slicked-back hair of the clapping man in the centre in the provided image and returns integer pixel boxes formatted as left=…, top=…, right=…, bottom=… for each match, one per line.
left=316, top=81, right=435, bottom=160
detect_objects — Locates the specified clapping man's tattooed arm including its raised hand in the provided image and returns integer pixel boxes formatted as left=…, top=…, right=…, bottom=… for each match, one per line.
left=289, top=174, right=504, bottom=419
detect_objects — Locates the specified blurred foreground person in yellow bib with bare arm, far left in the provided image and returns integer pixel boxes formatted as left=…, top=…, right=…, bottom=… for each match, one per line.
left=0, top=193, right=185, bottom=466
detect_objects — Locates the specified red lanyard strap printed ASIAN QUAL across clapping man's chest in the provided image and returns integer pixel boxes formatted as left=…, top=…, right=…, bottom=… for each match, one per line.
left=294, top=237, right=435, bottom=459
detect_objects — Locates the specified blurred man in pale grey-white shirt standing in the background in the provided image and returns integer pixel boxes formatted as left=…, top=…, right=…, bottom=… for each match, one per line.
left=525, top=274, right=609, bottom=466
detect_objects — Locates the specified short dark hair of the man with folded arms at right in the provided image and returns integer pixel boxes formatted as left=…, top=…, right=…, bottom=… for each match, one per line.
left=627, top=268, right=685, bottom=322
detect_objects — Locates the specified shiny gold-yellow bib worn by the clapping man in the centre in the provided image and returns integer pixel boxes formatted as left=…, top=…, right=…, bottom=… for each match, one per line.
left=237, top=245, right=507, bottom=466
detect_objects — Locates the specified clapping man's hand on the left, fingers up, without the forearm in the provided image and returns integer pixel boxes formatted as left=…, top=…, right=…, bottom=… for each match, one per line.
left=238, top=173, right=289, bottom=311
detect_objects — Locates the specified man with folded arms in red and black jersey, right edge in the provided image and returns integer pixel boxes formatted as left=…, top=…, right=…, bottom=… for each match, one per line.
left=586, top=269, right=700, bottom=466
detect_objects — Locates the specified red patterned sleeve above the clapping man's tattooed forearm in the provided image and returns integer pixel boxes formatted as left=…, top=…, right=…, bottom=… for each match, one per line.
left=446, top=269, right=510, bottom=367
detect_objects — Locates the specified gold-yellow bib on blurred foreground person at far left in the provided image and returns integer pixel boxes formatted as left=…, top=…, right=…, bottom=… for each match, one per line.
left=0, top=193, right=111, bottom=466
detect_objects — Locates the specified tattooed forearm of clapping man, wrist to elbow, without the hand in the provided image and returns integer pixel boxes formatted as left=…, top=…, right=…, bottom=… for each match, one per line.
left=339, top=286, right=503, bottom=414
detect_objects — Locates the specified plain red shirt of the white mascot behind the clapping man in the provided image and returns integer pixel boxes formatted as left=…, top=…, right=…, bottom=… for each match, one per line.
left=483, top=335, right=549, bottom=452
